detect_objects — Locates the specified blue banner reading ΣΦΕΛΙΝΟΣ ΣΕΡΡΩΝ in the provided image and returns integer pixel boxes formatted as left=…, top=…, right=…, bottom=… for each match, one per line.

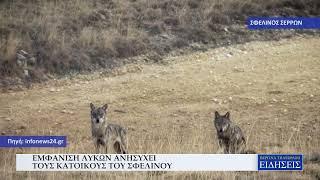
left=247, top=17, right=320, bottom=30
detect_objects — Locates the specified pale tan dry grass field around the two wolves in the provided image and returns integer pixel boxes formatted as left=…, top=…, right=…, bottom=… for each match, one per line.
left=0, top=36, right=320, bottom=179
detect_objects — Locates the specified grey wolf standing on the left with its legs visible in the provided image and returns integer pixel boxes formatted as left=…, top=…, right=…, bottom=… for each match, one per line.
left=90, top=103, right=128, bottom=154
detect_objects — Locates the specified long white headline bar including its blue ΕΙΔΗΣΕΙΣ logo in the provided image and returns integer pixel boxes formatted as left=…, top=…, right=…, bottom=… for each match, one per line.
left=16, top=154, right=303, bottom=171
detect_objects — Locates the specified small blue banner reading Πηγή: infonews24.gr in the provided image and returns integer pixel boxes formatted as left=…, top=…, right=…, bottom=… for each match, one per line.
left=0, top=136, right=67, bottom=148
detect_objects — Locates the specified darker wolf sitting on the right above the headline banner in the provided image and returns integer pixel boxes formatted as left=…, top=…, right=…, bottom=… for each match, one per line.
left=214, top=111, right=256, bottom=154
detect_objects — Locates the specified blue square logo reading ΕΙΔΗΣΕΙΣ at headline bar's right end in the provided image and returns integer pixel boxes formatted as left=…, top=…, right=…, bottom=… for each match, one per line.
left=258, top=154, right=303, bottom=171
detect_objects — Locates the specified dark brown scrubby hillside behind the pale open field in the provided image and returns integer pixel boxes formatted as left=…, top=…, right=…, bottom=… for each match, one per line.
left=0, top=0, right=320, bottom=86
